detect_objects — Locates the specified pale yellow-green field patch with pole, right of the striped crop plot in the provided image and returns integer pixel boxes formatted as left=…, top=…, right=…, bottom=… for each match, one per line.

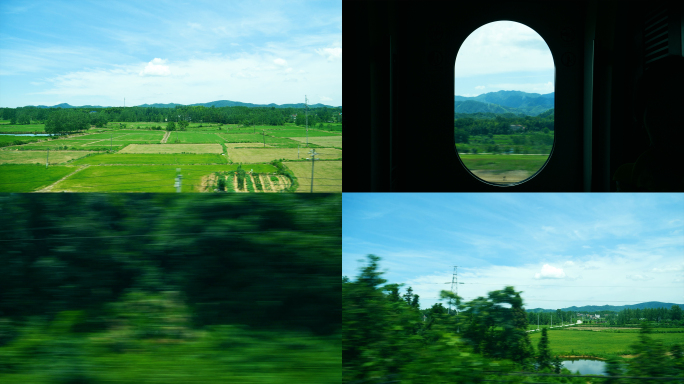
left=283, top=160, right=342, bottom=193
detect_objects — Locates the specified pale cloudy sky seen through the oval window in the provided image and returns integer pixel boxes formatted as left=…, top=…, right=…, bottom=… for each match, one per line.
left=454, top=20, right=555, bottom=97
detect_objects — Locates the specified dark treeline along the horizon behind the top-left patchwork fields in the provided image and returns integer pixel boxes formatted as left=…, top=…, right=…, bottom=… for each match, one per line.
left=0, top=106, right=342, bottom=126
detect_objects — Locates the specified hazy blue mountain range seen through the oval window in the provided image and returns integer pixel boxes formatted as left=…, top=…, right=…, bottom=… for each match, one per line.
left=454, top=91, right=555, bottom=116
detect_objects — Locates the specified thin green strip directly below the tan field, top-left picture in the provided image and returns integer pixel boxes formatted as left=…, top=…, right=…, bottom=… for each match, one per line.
left=71, top=153, right=227, bottom=165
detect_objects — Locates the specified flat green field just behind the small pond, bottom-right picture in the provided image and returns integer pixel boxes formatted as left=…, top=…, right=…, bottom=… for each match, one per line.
left=529, top=328, right=684, bottom=358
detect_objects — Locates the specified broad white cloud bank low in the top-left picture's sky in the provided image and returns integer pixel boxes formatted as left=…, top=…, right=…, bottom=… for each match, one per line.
left=33, top=54, right=342, bottom=106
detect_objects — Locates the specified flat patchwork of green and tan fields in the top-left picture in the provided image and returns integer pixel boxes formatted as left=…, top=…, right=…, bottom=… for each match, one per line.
left=0, top=122, right=342, bottom=192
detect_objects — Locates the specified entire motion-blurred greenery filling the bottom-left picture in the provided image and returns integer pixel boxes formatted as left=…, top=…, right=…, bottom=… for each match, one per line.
left=0, top=194, right=341, bottom=383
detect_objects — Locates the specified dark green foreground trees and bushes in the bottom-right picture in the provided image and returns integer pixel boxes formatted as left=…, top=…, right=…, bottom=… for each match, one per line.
left=342, top=255, right=684, bottom=384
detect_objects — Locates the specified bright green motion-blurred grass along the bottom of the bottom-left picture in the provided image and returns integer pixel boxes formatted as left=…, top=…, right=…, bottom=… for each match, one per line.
left=0, top=325, right=342, bottom=384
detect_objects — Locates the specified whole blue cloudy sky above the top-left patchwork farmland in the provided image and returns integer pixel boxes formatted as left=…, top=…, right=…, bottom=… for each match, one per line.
left=0, top=0, right=342, bottom=108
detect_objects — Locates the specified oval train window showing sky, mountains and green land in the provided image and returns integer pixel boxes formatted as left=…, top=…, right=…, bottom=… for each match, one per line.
left=454, top=21, right=555, bottom=186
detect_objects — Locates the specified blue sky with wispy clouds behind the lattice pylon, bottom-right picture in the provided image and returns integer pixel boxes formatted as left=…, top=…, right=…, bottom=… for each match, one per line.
left=342, top=193, right=684, bottom=309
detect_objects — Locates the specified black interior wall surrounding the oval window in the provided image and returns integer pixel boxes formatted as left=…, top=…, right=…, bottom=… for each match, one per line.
left=343, top=0, right=664, bottom=192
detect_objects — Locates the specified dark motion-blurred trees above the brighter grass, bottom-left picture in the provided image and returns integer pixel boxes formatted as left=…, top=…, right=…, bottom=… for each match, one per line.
left=0, top=194, right=341, bottom=334
